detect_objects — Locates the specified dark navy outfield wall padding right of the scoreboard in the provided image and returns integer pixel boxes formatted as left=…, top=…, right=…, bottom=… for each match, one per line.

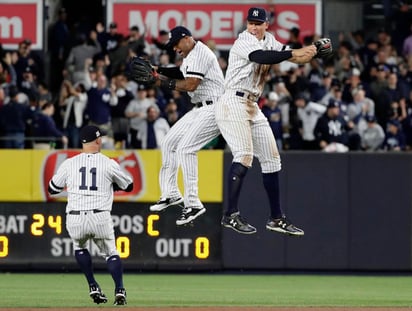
left=223, top=152, right=412, bottom=271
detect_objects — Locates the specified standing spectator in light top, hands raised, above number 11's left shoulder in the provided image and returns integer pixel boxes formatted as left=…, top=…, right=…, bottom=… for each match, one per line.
left=59, top=80, right=87, bottom=149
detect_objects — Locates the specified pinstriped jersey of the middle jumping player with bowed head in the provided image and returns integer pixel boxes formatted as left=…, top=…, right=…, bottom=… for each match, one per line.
left=180, top=41, right=224, bottom=103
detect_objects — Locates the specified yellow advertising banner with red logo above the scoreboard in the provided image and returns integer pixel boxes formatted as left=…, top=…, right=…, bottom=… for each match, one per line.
left=0, top=149, right=223, bottom=202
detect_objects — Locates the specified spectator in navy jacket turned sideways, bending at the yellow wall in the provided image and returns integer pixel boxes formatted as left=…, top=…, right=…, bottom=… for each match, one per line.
left=32, top=102, right=68, bottom=149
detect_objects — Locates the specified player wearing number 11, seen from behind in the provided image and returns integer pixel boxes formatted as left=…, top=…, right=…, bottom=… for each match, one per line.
left=48, top=125, right=133, bottom=305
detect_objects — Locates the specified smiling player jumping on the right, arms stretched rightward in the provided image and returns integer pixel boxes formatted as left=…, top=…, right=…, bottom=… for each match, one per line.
left=215, top=7, right=324, bottom=236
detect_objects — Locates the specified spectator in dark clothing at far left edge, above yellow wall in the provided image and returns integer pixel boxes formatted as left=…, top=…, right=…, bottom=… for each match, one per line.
left=0, top=86, right=33, bottom=149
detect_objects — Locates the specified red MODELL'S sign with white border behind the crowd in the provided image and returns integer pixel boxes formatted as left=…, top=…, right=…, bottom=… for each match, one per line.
left=107, top=0, right=322, bottom=49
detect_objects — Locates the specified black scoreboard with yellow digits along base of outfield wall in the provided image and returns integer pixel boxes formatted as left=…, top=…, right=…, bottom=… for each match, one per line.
left=0, top=202, right=222, bottom=270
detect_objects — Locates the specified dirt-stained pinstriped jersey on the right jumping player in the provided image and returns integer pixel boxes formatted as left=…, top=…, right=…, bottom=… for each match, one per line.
left=225, top=30, right=283, bottom=96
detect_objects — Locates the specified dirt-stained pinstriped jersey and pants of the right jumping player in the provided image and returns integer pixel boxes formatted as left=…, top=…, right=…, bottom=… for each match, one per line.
left=216, top=30, right=283, bottom=173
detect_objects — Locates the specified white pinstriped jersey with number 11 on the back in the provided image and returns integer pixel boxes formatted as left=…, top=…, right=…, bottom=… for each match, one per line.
left=50, top=153, right=132, bottom=212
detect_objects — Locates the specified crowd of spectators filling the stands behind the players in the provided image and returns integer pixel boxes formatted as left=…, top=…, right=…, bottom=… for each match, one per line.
left=0, top=6, right=412, bottom=152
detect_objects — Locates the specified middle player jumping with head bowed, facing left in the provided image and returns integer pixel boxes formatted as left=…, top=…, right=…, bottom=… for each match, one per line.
left=150, top=26, right=224, bottom=225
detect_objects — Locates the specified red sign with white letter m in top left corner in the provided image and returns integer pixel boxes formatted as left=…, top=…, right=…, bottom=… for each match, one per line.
left=0, top=0, right=43, bottom=50
